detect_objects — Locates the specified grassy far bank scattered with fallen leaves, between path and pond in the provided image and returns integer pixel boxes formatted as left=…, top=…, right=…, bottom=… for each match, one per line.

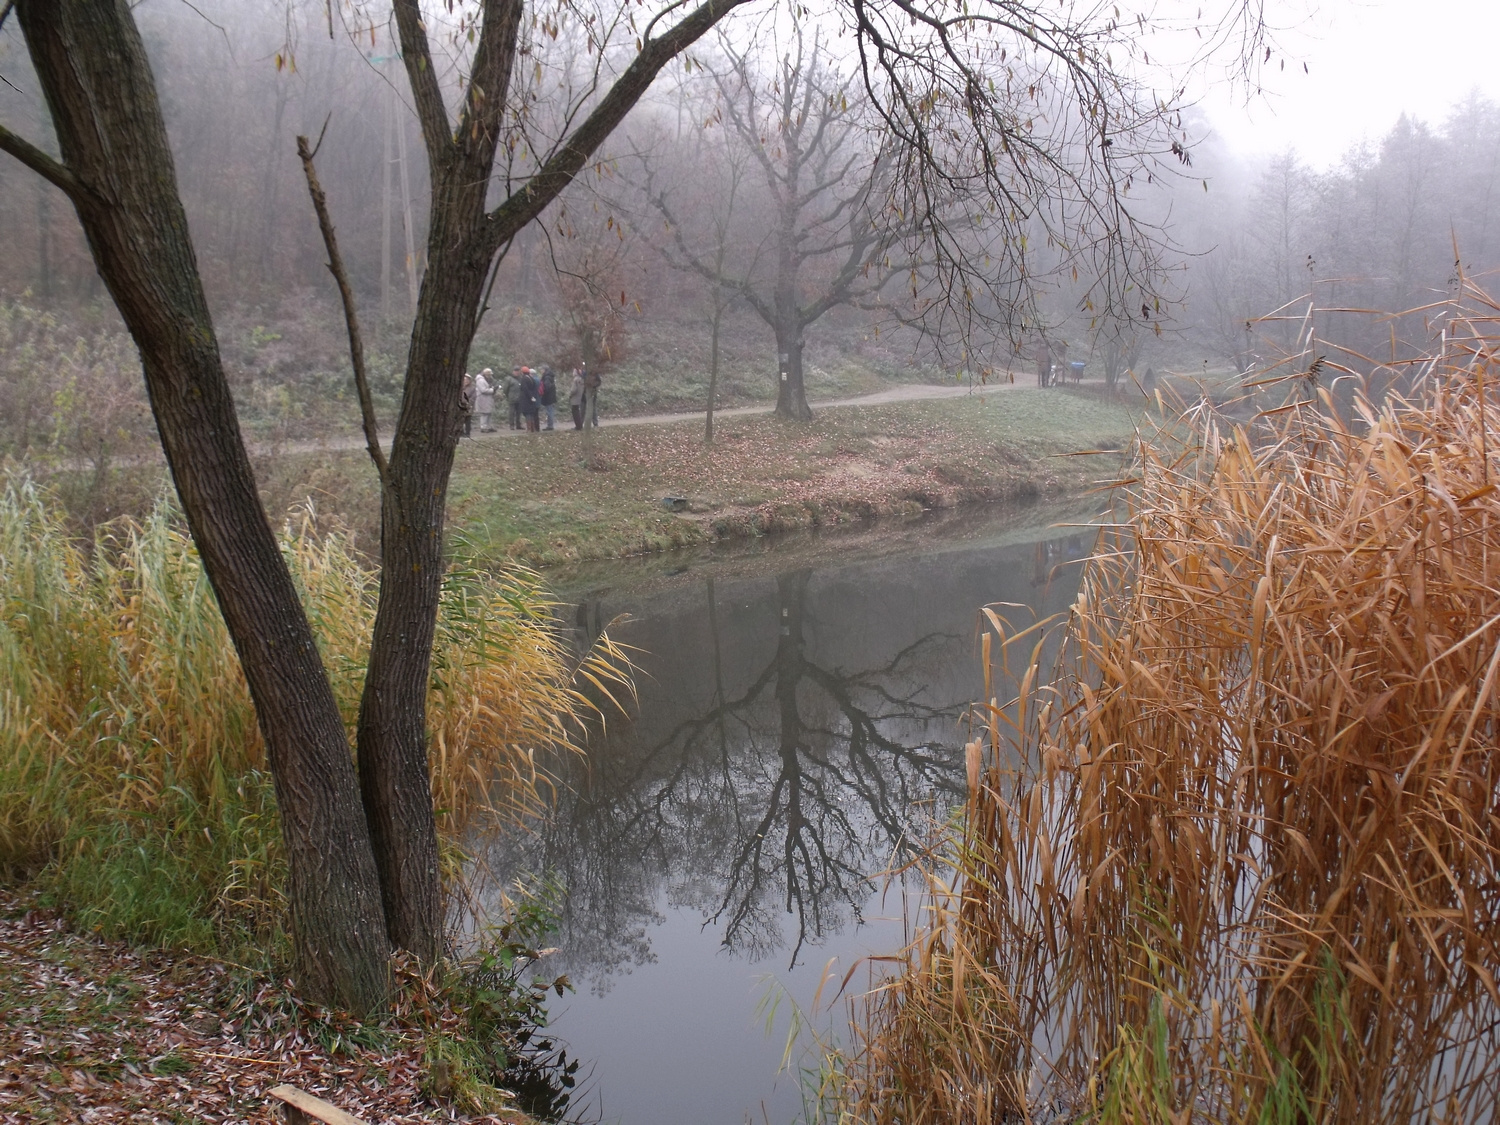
left=452, top=389, right=1136, bottom=566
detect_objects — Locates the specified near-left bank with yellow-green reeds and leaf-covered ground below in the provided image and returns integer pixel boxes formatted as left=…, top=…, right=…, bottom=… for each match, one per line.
left=0, top=479, right=618, bottom=1122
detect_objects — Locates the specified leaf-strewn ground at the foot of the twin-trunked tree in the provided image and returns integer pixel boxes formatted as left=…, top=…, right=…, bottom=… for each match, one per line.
left=0, top=891, right=540, bottom=1125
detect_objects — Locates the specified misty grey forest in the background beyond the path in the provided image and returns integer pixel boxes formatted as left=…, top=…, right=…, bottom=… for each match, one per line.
left=0, top=3, right=1500, bottom=458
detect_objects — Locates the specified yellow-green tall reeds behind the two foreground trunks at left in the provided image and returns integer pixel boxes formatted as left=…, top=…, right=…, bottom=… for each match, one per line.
left=0, top=479, right=623, bottom=963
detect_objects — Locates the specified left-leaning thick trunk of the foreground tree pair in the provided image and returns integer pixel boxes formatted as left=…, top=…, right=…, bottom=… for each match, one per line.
left=17, top=0, right=390, bottom=1013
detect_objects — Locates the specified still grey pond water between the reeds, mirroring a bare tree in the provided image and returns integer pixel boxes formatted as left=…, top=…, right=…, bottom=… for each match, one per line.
left=491, top=509, right=1092, bottom=1125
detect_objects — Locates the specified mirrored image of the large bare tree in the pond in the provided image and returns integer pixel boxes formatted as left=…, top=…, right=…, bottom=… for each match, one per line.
left=681, top=570, right=960, bottom=965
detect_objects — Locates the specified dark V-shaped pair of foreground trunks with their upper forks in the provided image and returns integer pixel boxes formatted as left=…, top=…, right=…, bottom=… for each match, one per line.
left=0, top=0, right=741, bottom=1011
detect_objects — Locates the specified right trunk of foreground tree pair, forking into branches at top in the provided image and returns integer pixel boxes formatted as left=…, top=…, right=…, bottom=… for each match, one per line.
left=359, top=0, right=746, bottom=960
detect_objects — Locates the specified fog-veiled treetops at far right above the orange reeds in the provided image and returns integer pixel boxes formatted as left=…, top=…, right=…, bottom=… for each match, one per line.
left=1178, top=95, right=1500, bottom=371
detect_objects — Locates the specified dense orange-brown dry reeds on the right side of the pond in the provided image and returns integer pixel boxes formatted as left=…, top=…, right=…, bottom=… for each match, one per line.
left=836, top=303, right=1500, bottom=1125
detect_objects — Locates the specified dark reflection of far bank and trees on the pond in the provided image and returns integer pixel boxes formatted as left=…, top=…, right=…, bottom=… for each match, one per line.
left=491, top=519, right=1086, bottom=992
